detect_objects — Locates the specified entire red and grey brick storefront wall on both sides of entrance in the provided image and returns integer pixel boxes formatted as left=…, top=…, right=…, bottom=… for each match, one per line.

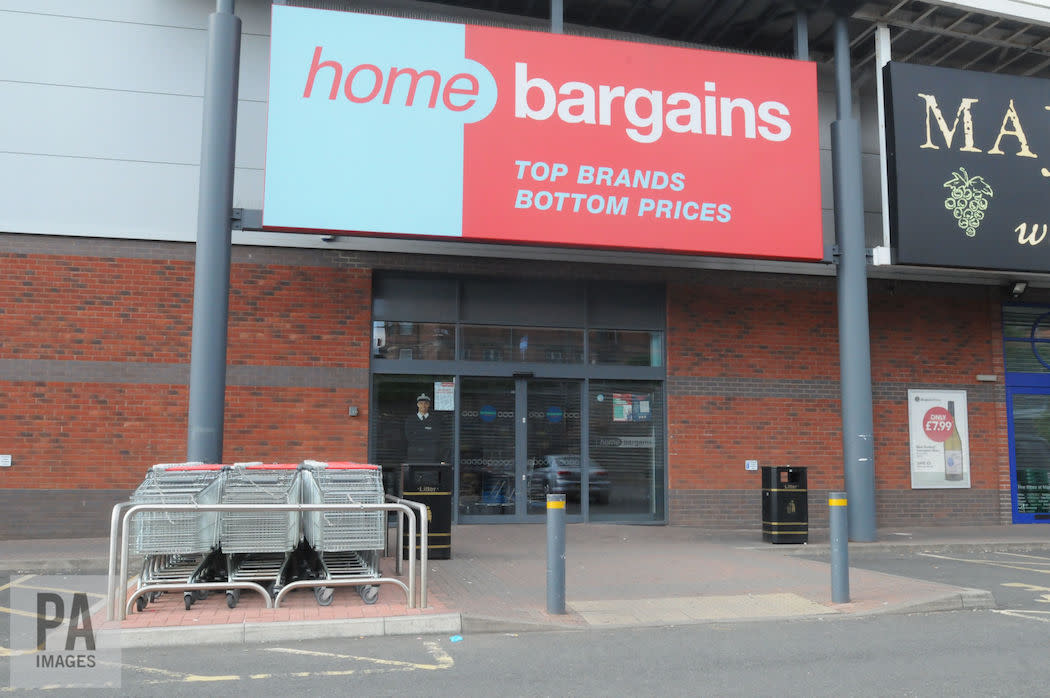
left=0, top=235, right=1010, bottom=537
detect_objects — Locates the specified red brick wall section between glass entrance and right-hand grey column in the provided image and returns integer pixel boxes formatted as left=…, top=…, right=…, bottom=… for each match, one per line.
left=667, top=281, right=842, bottom=495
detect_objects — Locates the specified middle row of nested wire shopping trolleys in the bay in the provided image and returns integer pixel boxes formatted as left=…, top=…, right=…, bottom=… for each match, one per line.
left=218, top=463, right=302, bottom=609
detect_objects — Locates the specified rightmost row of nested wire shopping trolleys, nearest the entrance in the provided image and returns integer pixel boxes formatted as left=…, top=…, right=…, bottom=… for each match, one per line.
left=302, top=461, right=386, bottom=606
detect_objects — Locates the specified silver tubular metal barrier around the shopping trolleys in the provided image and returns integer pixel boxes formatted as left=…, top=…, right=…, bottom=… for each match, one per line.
left=106, top=495, right=428, bottom=620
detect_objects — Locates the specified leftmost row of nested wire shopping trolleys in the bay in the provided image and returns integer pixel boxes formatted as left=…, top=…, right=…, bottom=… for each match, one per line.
left=128, top=463, right=223, bottom=611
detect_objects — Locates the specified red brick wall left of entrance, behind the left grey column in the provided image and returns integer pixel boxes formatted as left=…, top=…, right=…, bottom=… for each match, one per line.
left=0, top=244, right=372, bottom=490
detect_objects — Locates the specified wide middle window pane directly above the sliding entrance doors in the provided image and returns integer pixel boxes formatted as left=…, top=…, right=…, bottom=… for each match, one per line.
left=461, top=324, right=584, bottom=363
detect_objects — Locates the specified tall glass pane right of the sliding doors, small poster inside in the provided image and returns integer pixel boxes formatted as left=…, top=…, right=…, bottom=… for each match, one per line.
left=588, top=381, right=664, bottom=521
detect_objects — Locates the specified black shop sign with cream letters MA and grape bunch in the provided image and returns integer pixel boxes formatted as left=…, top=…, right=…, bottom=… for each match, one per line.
left=885, top=63, right=1050, bottom=272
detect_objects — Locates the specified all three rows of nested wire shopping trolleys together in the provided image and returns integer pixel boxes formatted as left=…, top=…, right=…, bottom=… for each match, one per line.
left=128, top=461, right=386, bottom=611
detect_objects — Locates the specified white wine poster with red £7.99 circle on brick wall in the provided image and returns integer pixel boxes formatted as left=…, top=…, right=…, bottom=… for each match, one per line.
left=908, top=390, right=970, bottom=489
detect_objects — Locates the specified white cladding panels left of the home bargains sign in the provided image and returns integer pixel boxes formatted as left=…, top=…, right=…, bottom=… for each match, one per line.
left=0, top=0, right=270, bottom=240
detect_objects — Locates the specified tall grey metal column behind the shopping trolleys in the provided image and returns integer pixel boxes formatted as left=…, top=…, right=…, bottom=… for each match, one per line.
left=186, top=0, right=240, bottom=463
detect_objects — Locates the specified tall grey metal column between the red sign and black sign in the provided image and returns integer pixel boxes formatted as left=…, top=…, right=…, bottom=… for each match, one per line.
left=832, top=10, right=876, bottom=541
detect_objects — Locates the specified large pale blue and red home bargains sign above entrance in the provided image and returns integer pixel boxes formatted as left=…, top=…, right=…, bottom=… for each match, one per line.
left=264, top=5, right=823, bottom=259
